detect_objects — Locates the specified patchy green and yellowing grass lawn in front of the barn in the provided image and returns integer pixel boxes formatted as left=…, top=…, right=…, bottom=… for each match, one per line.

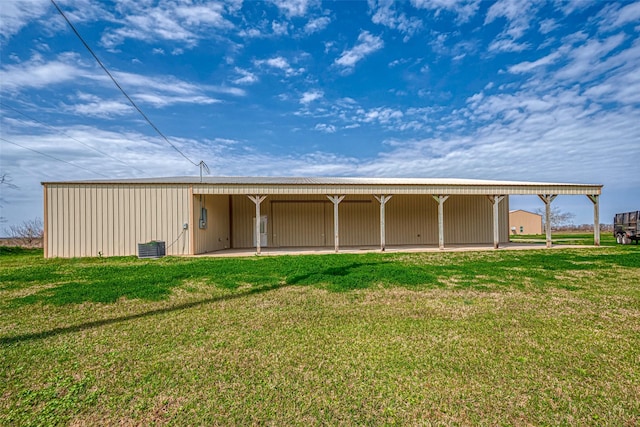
left=0, top=245, right=640, bottom=426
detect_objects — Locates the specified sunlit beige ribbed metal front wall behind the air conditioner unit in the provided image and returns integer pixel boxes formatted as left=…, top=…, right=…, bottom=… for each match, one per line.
left=45, top=184, right=189, bottom=257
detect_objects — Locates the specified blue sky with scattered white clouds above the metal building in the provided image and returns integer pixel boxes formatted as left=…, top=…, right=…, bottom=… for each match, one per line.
left=0, top=0, right=640, bottom=226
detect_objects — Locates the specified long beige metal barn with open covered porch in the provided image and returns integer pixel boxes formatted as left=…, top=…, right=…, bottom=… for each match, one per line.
left=42, top=177, right=602, bottom=257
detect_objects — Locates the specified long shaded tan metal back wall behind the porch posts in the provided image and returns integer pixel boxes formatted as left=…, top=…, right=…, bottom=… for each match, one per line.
left=232, top=195, right=509, bottom=248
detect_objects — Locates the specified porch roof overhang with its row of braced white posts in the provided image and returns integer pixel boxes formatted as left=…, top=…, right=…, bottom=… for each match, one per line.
left=189, top=177, right=602, bottom=254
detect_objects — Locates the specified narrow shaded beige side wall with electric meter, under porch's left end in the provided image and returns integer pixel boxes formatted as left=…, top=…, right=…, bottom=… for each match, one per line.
left=192, top=195, right=231, bottom=254
